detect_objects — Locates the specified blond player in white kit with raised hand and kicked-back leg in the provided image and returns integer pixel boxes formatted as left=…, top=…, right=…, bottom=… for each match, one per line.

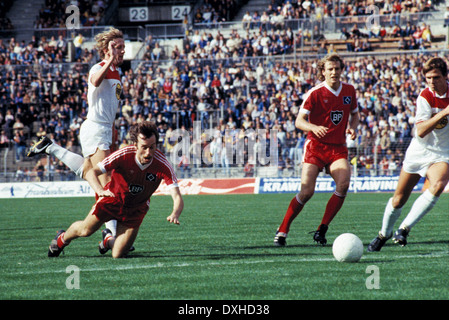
left=28, top=28, right=125, bottom=240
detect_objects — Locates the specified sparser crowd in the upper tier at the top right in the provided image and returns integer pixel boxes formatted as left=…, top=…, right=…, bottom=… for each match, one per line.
left=187, top=0, right=441, bottom=60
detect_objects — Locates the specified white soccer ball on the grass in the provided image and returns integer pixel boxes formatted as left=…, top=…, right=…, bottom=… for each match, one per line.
left=332, top=233, right=363, bottom=262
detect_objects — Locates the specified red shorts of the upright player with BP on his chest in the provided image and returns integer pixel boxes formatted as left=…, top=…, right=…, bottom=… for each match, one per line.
left=303, top=140, right=348, bottom=170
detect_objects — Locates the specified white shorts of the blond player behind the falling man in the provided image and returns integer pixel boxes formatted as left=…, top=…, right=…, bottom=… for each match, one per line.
left=79, top=119, right=112, bottom=158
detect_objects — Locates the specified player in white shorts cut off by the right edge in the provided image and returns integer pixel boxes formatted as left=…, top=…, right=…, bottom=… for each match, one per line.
left=368, top=58, right=449, bottom=252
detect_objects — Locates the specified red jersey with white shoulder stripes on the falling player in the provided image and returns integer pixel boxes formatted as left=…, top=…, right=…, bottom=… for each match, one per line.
left=98, top=146, right=178, bottom=207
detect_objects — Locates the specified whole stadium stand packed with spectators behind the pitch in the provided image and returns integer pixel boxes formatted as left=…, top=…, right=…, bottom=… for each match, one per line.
left=0, top=0, right=449, bottom=181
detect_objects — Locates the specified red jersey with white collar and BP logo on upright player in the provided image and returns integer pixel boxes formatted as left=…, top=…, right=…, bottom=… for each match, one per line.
left=300, top=81, right=357, bottom=144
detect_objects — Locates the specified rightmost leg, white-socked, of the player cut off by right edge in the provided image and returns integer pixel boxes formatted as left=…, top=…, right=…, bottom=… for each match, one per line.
left=393, top=162, right=449, bottom=246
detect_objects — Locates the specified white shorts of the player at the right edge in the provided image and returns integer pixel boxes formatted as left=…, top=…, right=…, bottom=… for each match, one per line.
left=402, top=139, right=449, bottom=177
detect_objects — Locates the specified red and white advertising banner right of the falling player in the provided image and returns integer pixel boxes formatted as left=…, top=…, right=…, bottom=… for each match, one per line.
left=154, top=178, right=256, bottom=195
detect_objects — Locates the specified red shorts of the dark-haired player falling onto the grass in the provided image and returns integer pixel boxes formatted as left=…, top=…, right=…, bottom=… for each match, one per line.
left=90, top=197, right=150, bottom=228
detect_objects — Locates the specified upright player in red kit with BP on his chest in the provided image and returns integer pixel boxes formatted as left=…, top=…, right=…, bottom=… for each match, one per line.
left=274, top=54, right=359, bottom=246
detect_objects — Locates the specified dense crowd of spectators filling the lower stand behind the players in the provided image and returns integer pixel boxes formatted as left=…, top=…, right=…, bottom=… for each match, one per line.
left=0, top=0, right=448, bottom=178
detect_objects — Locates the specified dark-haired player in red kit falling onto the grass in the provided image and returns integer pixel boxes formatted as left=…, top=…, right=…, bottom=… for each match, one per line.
left=48, top=121, right=184, bottom=258
